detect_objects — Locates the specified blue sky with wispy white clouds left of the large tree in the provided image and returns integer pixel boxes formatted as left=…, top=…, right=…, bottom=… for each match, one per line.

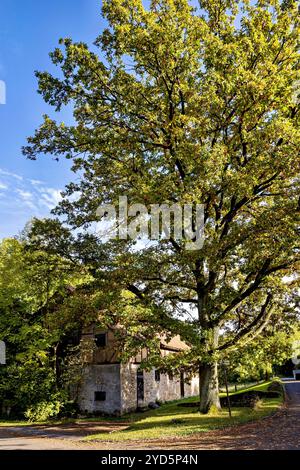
left=0, top=0, right=104, bottom=238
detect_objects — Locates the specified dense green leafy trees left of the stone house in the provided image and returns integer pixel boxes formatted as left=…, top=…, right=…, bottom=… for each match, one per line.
left=0, top=235, right=91, bottom=419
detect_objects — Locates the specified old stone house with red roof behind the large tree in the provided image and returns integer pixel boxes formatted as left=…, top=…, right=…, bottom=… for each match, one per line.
left=79, top=329, right=199, bottom=414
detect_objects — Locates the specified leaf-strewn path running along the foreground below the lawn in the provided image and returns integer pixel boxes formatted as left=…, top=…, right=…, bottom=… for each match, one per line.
left=0, top=381, right=300, bottom=450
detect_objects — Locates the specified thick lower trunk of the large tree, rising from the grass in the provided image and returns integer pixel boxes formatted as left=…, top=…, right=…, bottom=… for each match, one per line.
left=200, top=362, right=221, bottom=414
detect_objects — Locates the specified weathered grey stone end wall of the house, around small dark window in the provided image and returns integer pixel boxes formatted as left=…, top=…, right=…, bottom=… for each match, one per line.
left=79, top=364, right=121, bottom=414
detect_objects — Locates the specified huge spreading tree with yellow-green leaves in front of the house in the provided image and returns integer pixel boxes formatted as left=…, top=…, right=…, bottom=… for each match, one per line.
left=24, top=0, right=300, bottom=412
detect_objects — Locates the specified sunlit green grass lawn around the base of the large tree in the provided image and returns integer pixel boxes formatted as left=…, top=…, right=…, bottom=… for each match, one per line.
left=85, top=382, right=283, bottom=441
